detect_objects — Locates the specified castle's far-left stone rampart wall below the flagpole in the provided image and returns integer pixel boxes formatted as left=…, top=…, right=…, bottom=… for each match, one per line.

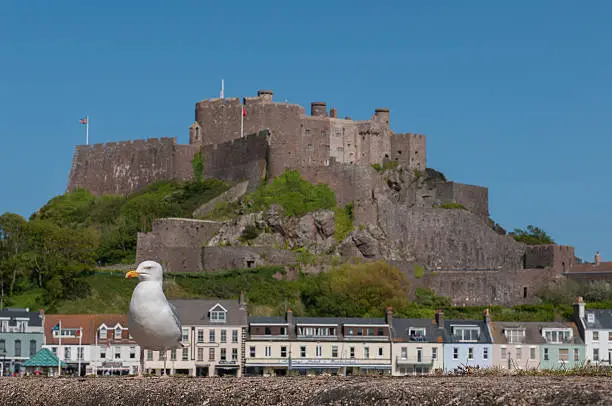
left=67, top=138, right=198, bottom=195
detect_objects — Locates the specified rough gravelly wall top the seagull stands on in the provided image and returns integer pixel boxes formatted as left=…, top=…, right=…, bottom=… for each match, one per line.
left=0, top=377, right=612, bottom=406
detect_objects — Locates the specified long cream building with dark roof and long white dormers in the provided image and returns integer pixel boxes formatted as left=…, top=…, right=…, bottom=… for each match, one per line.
left=245, top=308, right=393, bottom=376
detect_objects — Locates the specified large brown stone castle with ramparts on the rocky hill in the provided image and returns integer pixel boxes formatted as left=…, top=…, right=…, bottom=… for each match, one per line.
left=68, top=90, right=608, bottom=305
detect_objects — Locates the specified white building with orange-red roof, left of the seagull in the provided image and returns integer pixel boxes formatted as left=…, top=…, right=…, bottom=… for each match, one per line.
left=44, top=314, right=140, bottom=375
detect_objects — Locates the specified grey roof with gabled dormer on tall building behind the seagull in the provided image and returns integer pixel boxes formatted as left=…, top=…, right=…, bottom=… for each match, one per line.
left=170, top=299, right=247, bottom=326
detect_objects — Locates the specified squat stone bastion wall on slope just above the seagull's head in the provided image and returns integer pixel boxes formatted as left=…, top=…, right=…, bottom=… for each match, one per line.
left=136, top=218, right=222, bottom=272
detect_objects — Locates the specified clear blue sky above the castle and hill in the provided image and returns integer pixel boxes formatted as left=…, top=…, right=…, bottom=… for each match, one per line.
left=0, top=0, right=612, bottom=260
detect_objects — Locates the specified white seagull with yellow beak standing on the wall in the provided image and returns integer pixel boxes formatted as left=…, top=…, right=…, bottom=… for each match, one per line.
left=125, top=261, right=184, bottom=377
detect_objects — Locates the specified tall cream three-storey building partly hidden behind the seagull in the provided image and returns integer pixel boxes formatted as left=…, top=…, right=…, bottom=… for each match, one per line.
left=145, top=295, right=247, bottom=376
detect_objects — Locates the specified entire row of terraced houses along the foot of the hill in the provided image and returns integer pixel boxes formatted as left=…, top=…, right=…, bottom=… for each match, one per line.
left=0, top=297, right=612, bottom=376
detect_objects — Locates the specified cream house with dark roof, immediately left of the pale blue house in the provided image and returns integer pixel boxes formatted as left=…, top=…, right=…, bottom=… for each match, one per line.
left=391, top=311, right=446, bottom=376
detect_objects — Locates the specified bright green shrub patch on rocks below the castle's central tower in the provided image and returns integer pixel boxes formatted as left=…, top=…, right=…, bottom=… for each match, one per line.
left=245, top=171, right=336, bottom=216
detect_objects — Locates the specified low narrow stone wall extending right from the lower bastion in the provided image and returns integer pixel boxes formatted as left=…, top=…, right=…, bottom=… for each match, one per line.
left=201, top=247, right=296, bottom=271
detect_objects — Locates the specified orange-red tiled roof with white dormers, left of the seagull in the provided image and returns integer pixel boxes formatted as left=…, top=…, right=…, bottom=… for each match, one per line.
left=44, top=314, right=134, bottom=344
